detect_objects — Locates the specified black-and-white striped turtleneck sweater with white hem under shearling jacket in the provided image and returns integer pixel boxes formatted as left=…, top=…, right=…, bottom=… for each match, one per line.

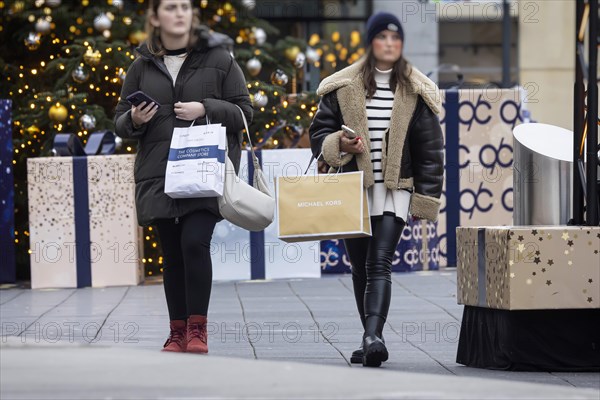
left=367, top=69, right=410, bottom=221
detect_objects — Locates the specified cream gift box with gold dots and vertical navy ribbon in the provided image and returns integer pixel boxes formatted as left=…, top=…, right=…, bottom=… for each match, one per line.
left=27, top=148, right=144, bottom=289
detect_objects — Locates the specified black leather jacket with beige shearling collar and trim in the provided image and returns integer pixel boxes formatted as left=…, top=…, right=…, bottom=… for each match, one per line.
left=310, top=59, right=444, bottom=221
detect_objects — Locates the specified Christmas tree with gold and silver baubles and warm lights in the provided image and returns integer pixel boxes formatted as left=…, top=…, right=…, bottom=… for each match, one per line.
left=0, top=0, right=322, bottom=278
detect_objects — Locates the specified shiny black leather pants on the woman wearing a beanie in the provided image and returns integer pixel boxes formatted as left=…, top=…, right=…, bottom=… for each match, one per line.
left=344, top=215, right=405, bottom=336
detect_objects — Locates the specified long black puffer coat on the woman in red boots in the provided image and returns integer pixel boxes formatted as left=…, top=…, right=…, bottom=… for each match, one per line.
left=115, top=27, right=252, bottom=225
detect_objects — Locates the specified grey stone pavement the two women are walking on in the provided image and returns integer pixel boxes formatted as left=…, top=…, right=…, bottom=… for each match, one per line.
left=0, top=270, right=600, bottom=399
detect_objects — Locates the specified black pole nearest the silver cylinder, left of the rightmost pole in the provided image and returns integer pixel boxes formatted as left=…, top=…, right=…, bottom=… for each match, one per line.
left=573, top=0, right=585, bottom=225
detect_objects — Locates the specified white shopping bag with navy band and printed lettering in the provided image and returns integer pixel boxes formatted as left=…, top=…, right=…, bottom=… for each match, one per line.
left=165, top=123, right=227, bottom=199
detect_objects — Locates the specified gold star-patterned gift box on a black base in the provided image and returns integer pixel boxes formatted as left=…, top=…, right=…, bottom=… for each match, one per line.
left=456, top=226, right=600, bottom=310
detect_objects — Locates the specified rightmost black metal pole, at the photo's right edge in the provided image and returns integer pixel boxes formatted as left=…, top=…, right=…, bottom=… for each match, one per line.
left=586, top=0, right=598, bottom=226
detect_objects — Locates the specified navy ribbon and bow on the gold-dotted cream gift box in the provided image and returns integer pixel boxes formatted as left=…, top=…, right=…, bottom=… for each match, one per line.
left=53, top=131, right=116, bottom=288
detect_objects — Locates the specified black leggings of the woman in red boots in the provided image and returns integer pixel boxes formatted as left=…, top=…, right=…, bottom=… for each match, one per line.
left=155, top=211, right=218, bottom=320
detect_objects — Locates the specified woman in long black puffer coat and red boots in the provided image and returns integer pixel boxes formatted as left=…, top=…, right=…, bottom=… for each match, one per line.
left=115, top=0, right=252, bottom=353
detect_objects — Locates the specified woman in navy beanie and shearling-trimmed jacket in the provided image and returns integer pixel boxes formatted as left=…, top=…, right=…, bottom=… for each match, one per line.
left=310, top=13, right=444, bottom=367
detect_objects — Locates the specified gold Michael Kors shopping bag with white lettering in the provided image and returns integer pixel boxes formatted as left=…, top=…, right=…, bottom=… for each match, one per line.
left=276, top=171, right=371, bottom=243
